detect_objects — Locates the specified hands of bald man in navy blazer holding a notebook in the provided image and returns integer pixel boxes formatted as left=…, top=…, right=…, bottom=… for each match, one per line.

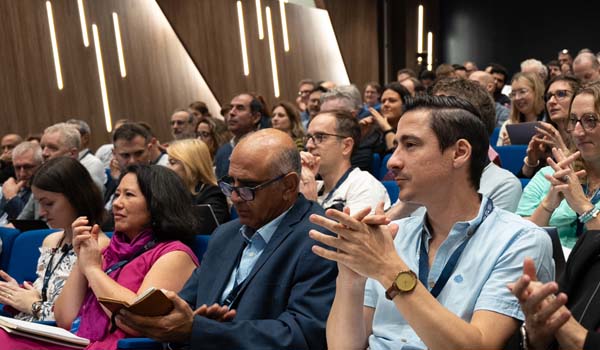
left=115, top=291, right=236, bottom=343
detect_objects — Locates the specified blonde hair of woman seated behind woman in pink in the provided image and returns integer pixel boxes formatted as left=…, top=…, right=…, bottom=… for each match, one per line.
left=167, top=139, right=217, bottom=194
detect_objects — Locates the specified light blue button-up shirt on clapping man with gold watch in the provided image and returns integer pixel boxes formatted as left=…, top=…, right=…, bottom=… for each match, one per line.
left=364, top=197, right=554, bottom=350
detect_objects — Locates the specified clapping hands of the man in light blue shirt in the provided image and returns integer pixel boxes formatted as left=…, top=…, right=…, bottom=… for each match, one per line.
left=309, top=203, right=400, bottom=282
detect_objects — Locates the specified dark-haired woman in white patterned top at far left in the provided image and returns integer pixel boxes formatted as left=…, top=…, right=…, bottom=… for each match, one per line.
left=0, top=157, right=108, bottom=322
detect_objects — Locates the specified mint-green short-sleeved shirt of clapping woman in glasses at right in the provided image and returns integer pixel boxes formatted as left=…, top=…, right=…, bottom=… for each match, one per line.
left=516, top=166, right=584, bottom=249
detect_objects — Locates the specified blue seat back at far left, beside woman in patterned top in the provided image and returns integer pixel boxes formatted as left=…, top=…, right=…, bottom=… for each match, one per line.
left=8, top=229, right=57, bottom=283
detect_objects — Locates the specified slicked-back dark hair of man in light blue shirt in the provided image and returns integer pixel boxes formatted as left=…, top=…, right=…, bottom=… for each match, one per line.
left=406, top=95, right=490, bottom=190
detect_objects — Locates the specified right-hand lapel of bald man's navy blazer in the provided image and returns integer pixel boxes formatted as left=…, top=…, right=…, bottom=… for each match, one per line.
left=234, top=195, right=310, bottom=304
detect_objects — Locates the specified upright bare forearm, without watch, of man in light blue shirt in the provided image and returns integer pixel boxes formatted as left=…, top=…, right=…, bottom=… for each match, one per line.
left=327, top=276, right=369, bottom=349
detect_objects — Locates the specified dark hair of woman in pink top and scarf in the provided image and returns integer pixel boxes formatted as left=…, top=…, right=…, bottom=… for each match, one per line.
left=119, top=165, right=196, bottom=245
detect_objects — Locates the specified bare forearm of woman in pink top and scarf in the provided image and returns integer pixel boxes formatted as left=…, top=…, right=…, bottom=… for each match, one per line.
left=54, top=264, right=87, bottom=329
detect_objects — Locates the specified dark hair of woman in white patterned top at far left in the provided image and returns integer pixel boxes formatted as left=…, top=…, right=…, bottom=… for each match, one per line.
left=31, top=157, right=106, bottom=224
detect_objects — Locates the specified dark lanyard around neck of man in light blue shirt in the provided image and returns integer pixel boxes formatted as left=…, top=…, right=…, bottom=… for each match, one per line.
left=419, top=199, right=494, bottom=298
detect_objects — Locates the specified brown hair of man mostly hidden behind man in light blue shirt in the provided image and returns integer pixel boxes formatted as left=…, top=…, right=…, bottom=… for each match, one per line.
left=432, top=78, right=496, bottom=135
